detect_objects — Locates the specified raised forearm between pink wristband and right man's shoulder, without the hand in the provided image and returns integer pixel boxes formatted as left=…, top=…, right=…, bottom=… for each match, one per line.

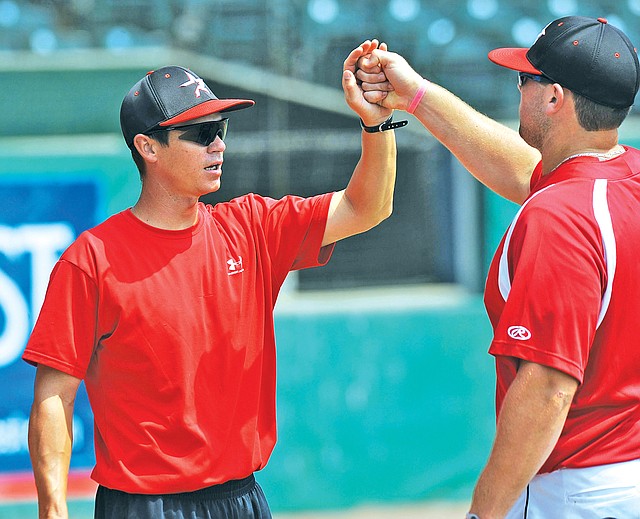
left=414, top=83, right=540, bottom=203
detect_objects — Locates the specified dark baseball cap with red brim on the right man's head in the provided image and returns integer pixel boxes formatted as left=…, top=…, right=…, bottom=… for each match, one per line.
left=489, top=16, right=640, bottom=108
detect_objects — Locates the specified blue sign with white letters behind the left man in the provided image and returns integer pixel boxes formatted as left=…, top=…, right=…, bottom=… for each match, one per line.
left=0, top=175, right=101, bottom=471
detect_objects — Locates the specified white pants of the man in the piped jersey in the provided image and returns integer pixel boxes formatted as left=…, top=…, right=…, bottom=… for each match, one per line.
left=505, top=459, right=640, bottom=519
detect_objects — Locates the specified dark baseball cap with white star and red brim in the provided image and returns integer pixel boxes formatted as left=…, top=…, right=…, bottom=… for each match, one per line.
left=120, top=66, right=255, bottom=148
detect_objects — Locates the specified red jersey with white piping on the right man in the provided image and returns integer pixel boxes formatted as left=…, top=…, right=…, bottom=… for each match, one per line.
left=485, top=148, right=640, bottom=473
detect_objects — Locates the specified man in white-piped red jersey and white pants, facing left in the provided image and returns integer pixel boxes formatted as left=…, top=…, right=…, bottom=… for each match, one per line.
left=357, top=16, right=640, bottom=519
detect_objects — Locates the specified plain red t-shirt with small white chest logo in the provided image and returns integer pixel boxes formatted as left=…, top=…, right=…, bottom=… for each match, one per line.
left=23, top=194, right=333, bottom=494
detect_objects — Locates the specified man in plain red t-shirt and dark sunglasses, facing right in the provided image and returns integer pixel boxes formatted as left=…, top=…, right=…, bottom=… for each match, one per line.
left=24, top=41, right=406, bottom=519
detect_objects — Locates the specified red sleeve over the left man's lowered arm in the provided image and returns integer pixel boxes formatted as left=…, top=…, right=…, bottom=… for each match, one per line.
left=22, top=260, right=97, bottom=379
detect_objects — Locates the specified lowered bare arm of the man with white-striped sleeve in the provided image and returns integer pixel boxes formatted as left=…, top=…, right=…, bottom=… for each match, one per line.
left=471, top=364, right=577, bottom=519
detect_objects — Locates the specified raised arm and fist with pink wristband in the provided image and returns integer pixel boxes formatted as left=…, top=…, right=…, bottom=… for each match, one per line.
left=357, top=49, right=540, bottom=203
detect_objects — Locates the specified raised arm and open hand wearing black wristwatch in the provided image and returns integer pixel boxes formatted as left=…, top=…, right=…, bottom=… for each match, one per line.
left=322, top=40, right=396, bottom=245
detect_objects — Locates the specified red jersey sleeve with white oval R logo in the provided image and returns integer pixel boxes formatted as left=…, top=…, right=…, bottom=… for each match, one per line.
left=489, top=192, right=606, bottom=382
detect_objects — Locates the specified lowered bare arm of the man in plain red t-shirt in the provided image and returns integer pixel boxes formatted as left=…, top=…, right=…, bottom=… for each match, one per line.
left=29, top=365, right=80, bottom=519
